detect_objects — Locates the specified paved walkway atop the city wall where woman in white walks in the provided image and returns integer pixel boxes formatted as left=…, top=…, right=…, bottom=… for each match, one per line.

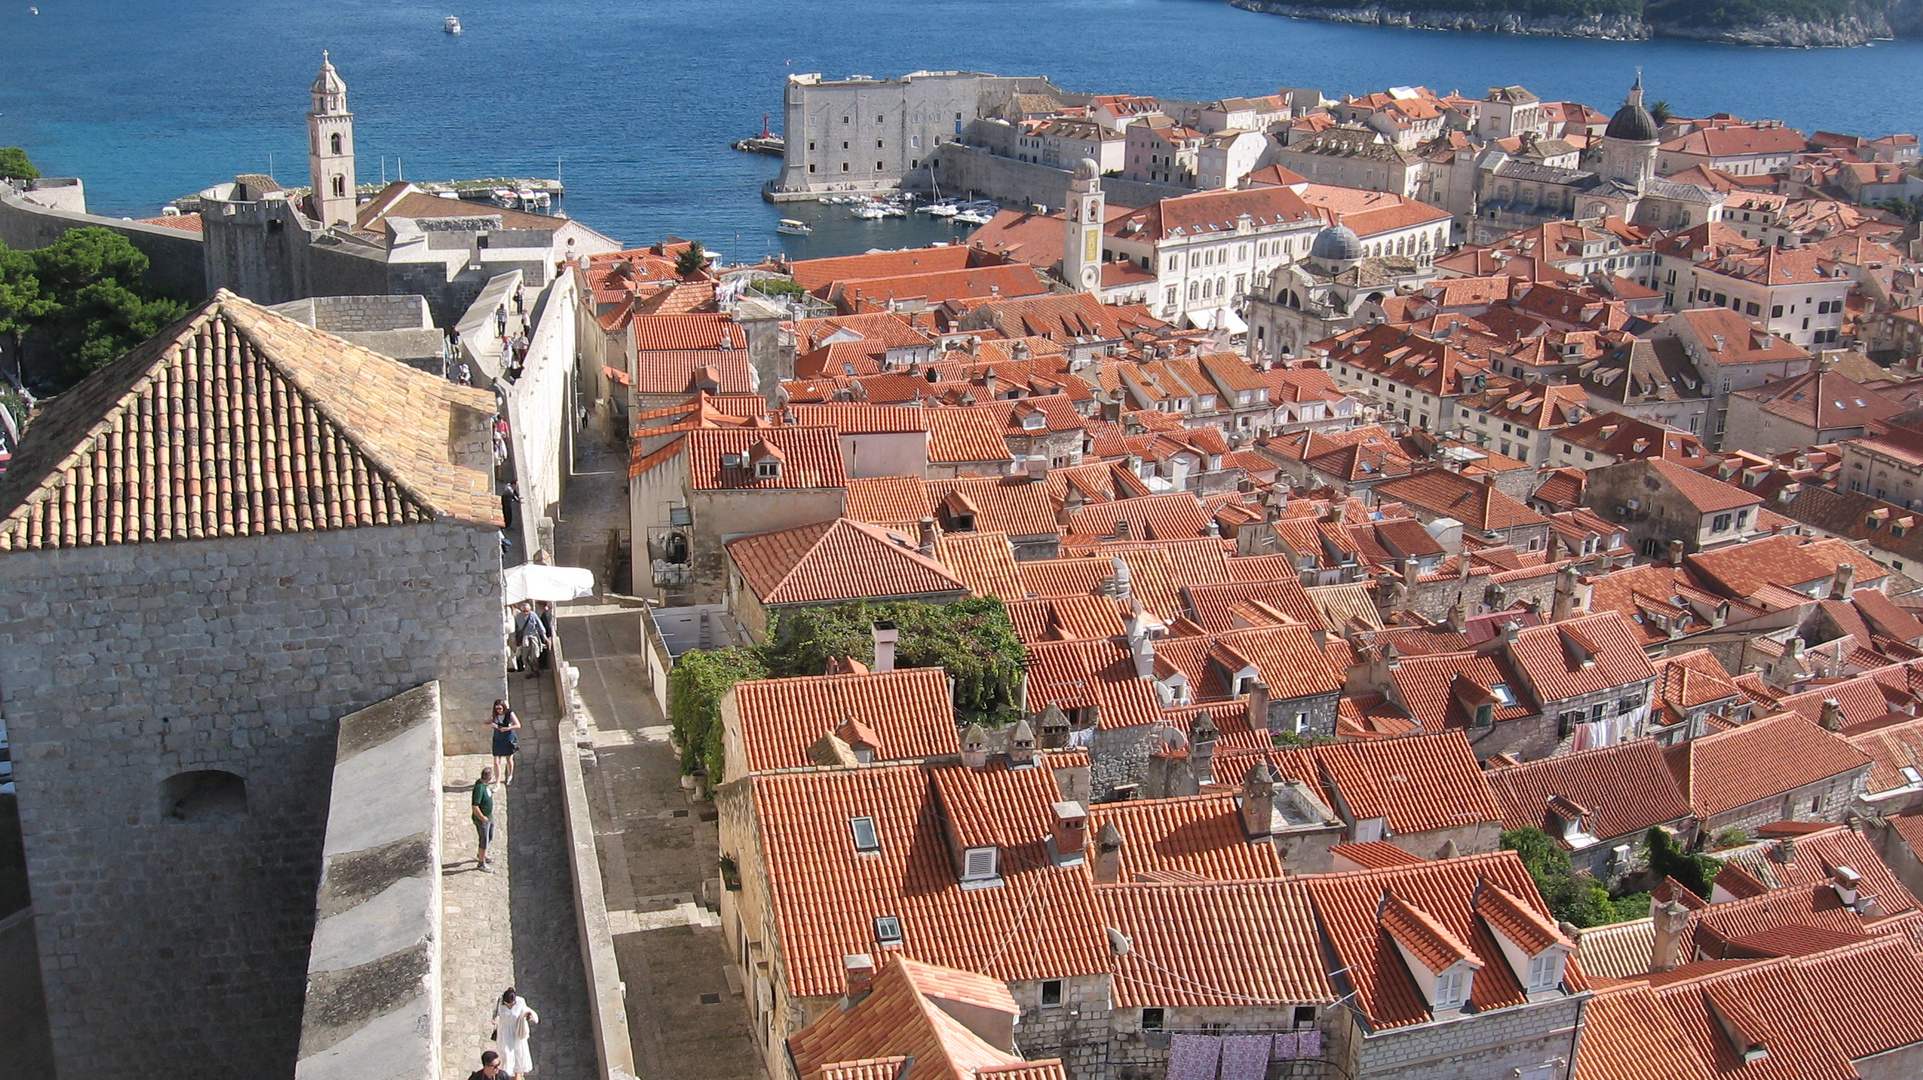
left=440, top=675, right=598, bottom=1080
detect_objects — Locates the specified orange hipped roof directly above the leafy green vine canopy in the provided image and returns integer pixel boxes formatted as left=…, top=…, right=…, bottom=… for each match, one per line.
left=727, top=517, right=967, bottom=603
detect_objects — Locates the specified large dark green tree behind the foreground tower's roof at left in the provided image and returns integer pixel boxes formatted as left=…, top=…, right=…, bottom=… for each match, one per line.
left=27, top=227, right=187, bottom=390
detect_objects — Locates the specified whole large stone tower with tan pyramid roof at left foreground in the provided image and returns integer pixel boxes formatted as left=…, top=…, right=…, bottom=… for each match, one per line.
left=0, top=292, right=506, bottom=1078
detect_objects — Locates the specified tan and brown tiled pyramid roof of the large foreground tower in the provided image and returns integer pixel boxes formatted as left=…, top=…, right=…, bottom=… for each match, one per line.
left=0, top=290, right=502, bottom=550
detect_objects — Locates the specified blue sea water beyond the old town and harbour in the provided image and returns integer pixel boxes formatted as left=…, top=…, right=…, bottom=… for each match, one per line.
left=0, top=0, right=1923, bottom=258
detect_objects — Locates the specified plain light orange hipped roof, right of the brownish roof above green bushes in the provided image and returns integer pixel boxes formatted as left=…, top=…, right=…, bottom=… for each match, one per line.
left=1663, top=713, right=1869, bottom=817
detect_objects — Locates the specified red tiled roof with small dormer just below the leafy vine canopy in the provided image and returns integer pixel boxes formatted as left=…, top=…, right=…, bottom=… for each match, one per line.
left=721, top=667, right=958, bottom=773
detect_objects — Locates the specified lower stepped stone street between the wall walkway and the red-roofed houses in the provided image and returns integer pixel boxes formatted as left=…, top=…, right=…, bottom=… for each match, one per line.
left=556, top=430, right=765, bottom=1080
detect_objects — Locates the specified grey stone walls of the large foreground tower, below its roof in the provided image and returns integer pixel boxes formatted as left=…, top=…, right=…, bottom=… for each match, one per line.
left=0, top=521, right=506, bottom=1078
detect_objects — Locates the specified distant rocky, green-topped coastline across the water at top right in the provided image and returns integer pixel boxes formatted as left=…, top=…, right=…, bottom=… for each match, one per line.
left=1229, top=0, right=1923, bottom=48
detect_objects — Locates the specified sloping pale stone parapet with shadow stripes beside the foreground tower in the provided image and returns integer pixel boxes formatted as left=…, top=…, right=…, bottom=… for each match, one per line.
left=294, top=682, right=442, bottom=1080
